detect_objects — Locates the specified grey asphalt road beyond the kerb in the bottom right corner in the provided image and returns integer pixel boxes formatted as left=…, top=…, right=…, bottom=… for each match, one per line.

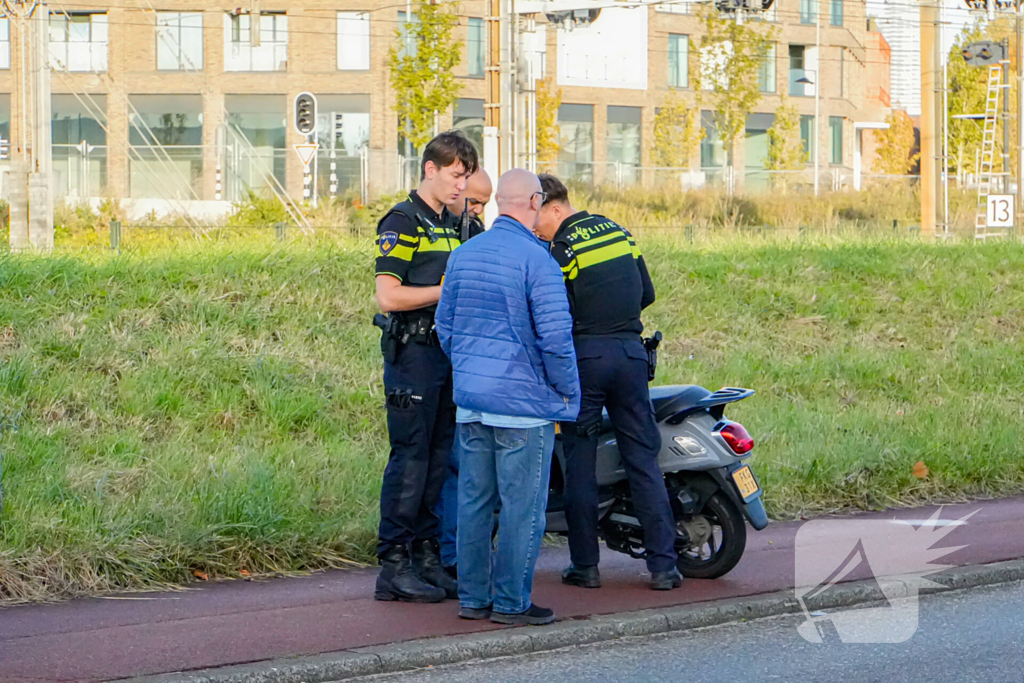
left=362, top=583, right=1024, bottom=683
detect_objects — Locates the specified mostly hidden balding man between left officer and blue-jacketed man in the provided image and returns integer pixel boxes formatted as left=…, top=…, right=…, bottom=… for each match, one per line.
left=435, top=168, right=494, bottom=579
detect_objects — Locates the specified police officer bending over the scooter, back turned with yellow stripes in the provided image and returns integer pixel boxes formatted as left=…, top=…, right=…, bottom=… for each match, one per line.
left=537, top=174, right=682, bottom=591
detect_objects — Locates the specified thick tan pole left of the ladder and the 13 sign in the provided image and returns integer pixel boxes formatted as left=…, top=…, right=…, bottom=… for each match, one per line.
left=921, top=0, right=942, bottom=237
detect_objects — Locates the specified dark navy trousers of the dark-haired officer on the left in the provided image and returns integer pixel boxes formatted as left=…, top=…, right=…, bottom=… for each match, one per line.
left=377, top=341, right=456, bottom=556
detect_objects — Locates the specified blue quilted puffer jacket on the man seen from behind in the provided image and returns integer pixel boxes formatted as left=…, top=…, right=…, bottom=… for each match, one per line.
left=434, top=216, right=580, bottom=422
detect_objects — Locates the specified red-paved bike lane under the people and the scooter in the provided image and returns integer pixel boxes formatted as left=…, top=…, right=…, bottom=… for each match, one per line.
left=0, top=497, right=1024, bottom=683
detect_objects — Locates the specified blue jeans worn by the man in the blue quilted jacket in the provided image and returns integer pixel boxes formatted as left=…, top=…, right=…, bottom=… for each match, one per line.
left=456, top=422, right=555, bottom=614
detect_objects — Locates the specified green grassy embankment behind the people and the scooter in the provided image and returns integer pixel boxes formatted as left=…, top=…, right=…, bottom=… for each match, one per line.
left=0, top=236, right=1024, bottom=601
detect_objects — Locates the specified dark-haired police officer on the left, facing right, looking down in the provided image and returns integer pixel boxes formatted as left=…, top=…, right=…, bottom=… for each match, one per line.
left=375, top=131, right=478, bottom=602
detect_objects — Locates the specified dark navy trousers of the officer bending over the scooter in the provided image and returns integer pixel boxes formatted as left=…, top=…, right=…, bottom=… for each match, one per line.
left=561, top=337, right=677, bottom=572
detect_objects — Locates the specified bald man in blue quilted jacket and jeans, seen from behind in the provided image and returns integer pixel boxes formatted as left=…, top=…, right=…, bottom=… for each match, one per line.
left=434, top=169, right=580, bottom=625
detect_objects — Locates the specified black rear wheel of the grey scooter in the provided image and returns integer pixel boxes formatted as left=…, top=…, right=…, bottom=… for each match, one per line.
left=676, top=492, right=746, bottom=579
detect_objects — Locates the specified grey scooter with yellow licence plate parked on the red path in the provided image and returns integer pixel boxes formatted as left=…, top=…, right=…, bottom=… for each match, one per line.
left=547, top=334, right=768, bottom=579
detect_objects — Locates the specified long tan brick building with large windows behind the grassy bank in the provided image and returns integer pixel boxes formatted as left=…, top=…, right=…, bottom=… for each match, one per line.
left=0, top=0, right=888, bottom=206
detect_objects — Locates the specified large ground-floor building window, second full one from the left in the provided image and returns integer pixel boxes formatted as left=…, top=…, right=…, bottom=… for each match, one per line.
left=128, top=95, right=203, bottom=200
